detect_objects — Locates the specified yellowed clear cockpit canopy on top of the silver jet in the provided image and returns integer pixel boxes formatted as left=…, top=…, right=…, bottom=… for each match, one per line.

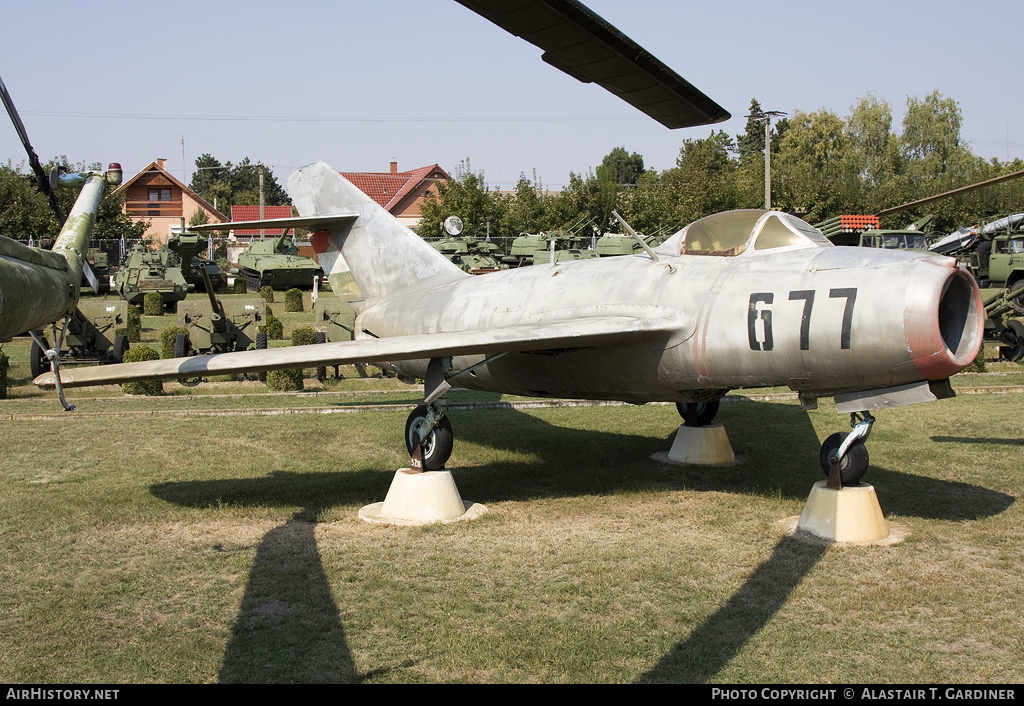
left=656, top=209, right=831, bottom=257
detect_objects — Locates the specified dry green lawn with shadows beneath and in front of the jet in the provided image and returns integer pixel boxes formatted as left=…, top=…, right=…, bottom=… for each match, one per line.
left=0, top=381, right=1024, bottom=682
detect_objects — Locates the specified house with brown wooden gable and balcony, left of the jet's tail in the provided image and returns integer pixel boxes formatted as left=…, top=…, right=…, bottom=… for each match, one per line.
left=114, top=159, right=227, bottom=243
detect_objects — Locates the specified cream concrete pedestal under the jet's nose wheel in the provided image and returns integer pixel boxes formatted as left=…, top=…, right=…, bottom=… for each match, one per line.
left=797, top=481, right=889, bottom=543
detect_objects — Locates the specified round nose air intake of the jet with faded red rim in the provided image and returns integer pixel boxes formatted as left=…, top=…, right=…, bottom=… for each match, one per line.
left=903, top=262, right=984, bottom=380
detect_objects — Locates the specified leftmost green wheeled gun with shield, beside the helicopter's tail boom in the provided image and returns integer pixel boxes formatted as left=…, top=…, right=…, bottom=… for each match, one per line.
left=29, top=300, right=129, bottom=378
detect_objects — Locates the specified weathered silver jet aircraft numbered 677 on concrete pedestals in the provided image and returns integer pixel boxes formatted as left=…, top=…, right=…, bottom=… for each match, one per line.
left=36, top=162, right=984, bottom=484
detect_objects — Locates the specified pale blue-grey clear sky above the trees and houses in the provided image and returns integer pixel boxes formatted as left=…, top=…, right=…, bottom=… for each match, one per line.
left=0, top=0, right=1024, bottom=190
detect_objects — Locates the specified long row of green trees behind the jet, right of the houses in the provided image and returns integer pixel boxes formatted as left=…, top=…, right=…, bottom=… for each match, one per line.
left=419, top=91, right=1024, bottom=238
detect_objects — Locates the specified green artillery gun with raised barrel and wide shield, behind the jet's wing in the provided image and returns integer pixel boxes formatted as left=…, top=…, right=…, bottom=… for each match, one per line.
left=174, top=264, right=266, bottom=358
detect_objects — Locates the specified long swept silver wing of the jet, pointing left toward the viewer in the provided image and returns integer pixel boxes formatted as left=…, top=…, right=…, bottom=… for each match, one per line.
left=35, top=313, right=695, bottom=389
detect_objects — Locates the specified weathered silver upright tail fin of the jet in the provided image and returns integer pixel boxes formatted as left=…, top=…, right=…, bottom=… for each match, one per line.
left=288, top=162, right=471, bottom=308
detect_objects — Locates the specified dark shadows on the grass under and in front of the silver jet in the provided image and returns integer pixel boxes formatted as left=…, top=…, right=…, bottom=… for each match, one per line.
left=151, top=403, right=1015, bottom=682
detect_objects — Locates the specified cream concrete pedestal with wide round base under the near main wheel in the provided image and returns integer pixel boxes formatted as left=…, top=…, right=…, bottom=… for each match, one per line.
left=359, top=468, right=487, bottom=526
